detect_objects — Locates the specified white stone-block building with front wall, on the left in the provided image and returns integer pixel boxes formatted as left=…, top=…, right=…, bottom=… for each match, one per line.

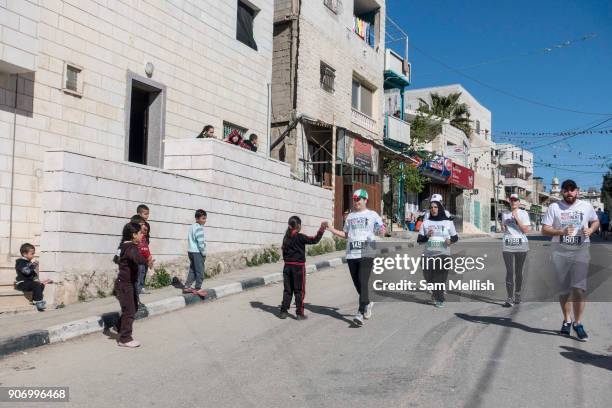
left=0, top=0, right=331, bottom=306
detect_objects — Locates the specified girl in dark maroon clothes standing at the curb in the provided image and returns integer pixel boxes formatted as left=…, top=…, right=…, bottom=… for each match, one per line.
left=113, top=222, right=147, bottom=348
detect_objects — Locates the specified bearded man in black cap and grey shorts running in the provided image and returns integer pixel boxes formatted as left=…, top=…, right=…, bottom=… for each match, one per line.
left=542, top=180, right=599, bottom=341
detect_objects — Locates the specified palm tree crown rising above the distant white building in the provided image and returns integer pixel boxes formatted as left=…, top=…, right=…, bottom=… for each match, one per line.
left=417, top=92, right=472, bottom=137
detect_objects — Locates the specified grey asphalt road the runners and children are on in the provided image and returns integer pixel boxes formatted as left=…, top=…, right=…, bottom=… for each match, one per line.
left=0, top=239, right=612, bottom=408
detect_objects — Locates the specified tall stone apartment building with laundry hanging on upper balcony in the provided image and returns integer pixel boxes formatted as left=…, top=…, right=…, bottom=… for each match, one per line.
left=271, top=0, right=385, bottom=225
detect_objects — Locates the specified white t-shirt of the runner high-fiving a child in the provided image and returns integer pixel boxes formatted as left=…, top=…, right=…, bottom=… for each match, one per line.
left=344, top=210, right=383, bottom=259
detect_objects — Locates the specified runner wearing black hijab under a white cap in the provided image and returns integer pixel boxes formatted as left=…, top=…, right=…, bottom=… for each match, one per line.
left=417, top=197, right=459, bottom=308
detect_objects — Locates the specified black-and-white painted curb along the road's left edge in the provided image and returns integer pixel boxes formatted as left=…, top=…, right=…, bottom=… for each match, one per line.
left=0, top=242, right=415, bottom=358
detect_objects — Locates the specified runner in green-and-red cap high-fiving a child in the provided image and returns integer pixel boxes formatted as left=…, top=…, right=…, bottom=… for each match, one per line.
left=328, top=189, right=385, bottom=326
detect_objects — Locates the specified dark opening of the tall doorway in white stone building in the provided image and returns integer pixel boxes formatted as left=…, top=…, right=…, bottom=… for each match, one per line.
left=128, top=86, right=151, bottom=164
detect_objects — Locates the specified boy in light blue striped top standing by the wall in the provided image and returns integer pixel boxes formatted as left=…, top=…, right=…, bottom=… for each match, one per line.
left=183, top=209, right=208, bottom=297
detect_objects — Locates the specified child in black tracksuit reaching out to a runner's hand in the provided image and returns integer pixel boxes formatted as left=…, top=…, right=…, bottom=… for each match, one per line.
left=278, top=215, right=327, bottom=320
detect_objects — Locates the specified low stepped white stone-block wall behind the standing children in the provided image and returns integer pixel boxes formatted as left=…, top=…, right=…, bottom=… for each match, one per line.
left=40, top=146, right=332, bottom=303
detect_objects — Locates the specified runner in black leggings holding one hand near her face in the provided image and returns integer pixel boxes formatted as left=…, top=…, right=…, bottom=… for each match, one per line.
left=502, top=194, right=531, bottom=307
